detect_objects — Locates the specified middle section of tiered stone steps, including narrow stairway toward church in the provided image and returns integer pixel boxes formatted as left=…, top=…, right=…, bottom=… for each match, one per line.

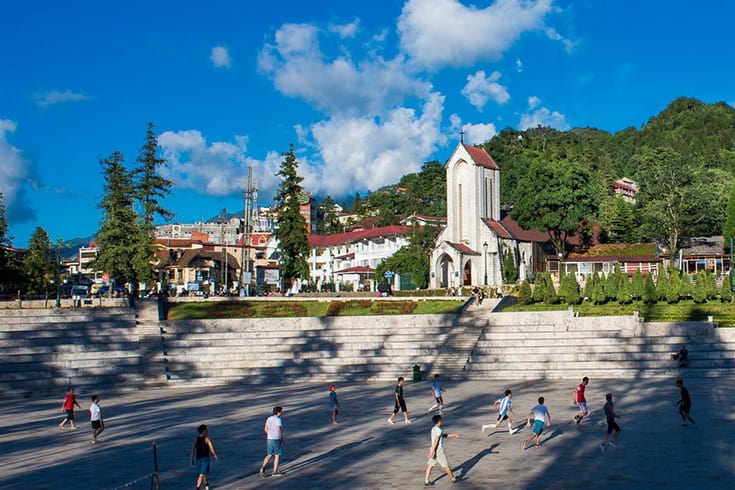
left=158, top=296, right=492, bottom=384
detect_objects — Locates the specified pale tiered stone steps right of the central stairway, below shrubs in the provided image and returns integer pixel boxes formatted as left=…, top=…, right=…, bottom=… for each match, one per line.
left=465, top=311, right=735, bottom=379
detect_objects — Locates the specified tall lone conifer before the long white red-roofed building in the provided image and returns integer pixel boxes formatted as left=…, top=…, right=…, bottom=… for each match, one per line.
left=274, top=144, right=311, bottom=287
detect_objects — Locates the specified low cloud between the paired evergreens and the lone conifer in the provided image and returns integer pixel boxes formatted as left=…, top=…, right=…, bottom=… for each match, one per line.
left=158, top=130, right=282, bottom=196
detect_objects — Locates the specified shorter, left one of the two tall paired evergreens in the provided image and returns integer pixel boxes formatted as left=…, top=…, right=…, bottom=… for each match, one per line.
left=95, top=151, right=142, bottom=288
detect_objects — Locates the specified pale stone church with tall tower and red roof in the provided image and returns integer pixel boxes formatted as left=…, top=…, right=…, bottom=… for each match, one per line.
left=429, top=143, right=548, bottom=288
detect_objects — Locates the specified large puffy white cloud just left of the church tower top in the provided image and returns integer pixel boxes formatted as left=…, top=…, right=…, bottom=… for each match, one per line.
left=304, top=93, right=446, bottom=195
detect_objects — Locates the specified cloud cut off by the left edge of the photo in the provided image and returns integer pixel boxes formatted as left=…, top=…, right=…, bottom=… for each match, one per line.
left=0, top=119, right=36, bottom=222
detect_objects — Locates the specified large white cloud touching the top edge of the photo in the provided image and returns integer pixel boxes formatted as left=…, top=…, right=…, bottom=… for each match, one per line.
left=398, top=0, right=556, bottom=69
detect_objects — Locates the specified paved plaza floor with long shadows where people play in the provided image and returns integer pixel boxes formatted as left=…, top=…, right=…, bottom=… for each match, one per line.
left=0, top=373, right=735, bottom=490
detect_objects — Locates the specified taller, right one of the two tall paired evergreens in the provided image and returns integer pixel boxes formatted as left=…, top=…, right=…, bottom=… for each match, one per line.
left=132, top=122, right=174, bottom=289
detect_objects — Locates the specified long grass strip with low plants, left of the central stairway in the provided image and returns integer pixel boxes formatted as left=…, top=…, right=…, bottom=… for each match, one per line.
left=167, top=299, right=464, bottom=320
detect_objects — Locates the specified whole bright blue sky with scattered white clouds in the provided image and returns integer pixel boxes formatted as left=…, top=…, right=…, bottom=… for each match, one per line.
left=0, top=0, right=735, bottom=246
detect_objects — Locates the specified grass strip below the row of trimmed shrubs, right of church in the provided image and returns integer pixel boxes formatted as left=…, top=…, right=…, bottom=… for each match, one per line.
left=503, top=301, right=735, bottom=327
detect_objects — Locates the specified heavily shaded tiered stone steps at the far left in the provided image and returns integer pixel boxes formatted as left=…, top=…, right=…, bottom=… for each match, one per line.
left=0, top=308, right=142, bottom=392
